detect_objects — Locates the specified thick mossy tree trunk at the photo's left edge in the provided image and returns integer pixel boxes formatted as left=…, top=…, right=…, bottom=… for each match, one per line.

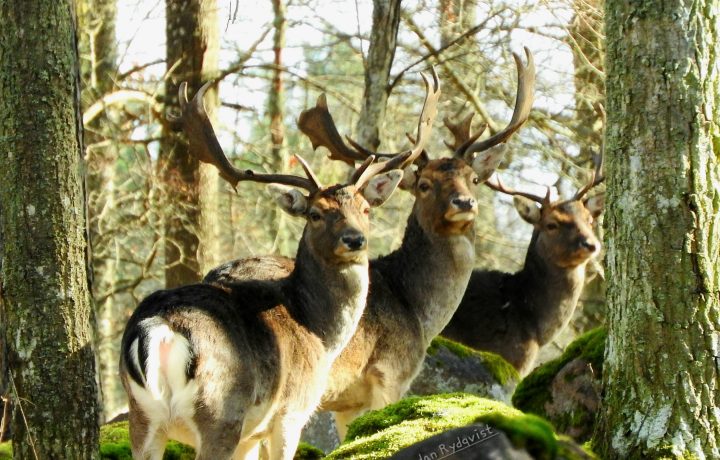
left=0, top=0, right=100, bottom=459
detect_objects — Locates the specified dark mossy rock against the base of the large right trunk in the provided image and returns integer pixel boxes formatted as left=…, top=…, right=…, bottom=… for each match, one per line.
left=512, top=328, right=607, bottom=441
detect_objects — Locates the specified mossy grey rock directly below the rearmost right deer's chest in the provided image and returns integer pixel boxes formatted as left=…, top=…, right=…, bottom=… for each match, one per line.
left=409, top=337, right=519, bottom=402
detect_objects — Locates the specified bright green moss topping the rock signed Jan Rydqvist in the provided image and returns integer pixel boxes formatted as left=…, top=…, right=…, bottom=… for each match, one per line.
left=327, top=393, right=592, bottom=460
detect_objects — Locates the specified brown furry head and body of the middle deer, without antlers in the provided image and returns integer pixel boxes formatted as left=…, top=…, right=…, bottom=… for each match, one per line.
left=204, top=158, right=484, bottom=434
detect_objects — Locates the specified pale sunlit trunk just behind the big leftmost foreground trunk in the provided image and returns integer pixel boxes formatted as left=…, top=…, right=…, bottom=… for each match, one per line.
left=76, top=0, right=126, bottom=419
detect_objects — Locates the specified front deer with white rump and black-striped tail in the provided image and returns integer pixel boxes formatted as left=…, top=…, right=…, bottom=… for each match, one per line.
left=120, top=84, right=414, bottom=460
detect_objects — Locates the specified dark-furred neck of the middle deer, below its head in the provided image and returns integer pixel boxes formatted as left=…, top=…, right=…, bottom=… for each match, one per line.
left=371, top=213, right=475, bottom=345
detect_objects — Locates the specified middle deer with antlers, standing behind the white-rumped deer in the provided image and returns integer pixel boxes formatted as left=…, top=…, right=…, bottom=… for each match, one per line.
left=204, top=50, right=535, bottom=439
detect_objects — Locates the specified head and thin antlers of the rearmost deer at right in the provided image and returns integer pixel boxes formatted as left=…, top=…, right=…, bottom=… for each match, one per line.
left=486, top=155, right=604, bottom=268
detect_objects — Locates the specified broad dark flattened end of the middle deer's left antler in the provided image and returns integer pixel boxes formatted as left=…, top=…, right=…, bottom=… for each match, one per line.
left=297, top=93, right=370, bottom=166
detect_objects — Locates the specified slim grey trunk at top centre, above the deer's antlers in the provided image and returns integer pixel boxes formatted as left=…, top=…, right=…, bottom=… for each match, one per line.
left=356, top=0, right=401, bottom=150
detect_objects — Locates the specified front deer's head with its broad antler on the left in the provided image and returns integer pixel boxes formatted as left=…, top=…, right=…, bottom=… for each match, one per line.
left=169, top=83, right=409, bottom=264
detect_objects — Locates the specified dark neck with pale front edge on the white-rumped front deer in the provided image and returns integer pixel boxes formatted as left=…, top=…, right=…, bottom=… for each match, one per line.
left=287, top=230, right=369, bottom=360
